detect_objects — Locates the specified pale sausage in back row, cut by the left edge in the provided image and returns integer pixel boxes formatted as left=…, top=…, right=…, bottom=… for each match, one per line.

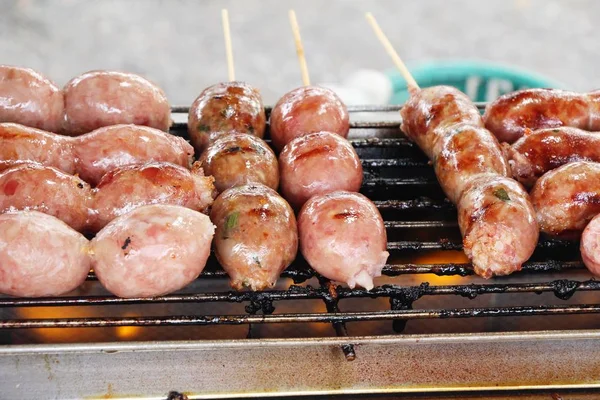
left=0, top=65, right=64, bottom=132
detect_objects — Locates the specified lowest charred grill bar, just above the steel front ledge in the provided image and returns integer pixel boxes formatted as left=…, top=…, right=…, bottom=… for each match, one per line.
left=0, top=304, right=600, bottom=329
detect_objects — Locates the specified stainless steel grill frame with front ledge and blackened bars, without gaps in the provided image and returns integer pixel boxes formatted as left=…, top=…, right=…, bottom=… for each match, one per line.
left=0, top=104, right=600, bottom=399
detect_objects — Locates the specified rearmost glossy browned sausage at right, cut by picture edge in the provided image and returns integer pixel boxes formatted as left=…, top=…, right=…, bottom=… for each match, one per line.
left=483, top=89, right=600, bottom=143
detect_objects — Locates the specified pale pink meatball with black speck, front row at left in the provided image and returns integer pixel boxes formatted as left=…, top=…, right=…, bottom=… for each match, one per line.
left=91, top=205, right=214, bottom=297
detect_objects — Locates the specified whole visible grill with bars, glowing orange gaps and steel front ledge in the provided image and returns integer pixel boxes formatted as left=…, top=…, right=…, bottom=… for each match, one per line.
left=0, top=105, right=600, bottom=398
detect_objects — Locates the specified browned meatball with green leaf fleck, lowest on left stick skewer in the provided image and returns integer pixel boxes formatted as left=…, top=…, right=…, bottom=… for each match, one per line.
left=210, top=184, right=298, bottom=290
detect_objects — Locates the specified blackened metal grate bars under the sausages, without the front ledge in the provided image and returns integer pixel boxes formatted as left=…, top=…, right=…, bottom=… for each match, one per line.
left=0, top=104, right=600, bottom=360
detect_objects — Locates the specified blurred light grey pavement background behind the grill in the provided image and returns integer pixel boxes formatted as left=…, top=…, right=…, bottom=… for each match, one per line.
left=0, top=0, right=600, bottom=105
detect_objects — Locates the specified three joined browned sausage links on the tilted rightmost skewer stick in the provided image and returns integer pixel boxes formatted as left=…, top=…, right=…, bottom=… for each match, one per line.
left=401, top=86, right=538, bottom=278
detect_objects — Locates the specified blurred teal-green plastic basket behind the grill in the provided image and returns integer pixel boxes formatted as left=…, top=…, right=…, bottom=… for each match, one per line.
left=388, top=61, right=564, bottom=104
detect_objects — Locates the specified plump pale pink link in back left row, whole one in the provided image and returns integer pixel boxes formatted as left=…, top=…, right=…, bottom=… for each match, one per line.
left=64, top=71, right=172, bottom=136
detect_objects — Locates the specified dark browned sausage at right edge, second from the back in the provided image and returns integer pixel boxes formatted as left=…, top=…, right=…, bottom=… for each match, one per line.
left=505, top=126, right=600, bottom=187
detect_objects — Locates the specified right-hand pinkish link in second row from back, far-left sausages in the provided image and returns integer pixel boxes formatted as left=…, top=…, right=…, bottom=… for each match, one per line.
left=74, top=125, right=194, bottom=185
